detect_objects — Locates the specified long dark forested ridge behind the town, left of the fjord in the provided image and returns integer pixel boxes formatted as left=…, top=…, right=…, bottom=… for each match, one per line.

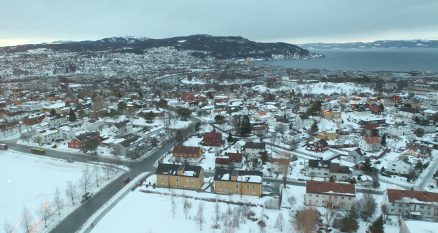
left=0, top=35, right=321, bottom=60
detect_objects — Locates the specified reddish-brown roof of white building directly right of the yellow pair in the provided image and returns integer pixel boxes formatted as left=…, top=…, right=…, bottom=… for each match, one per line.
left=306, top=180, right=356, bottom=196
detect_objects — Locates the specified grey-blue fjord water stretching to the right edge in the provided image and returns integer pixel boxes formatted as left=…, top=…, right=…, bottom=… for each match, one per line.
left=259, top=48, right=438, bottom=72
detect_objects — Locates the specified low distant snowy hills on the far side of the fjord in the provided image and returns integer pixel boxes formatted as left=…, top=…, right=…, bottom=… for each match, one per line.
left=299, top=40, right=438, bottom=50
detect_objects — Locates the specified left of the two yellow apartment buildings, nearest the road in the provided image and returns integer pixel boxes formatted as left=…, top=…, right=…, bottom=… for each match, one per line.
left=155, top=163, right=204, bottom=190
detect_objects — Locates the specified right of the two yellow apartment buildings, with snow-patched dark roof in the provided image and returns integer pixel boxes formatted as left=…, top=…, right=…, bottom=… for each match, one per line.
left=214, top=168, right=263, bottom=196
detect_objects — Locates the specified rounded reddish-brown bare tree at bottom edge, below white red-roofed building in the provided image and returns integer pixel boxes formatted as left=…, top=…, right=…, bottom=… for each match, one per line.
left=295, top=207, right=319, bottom=233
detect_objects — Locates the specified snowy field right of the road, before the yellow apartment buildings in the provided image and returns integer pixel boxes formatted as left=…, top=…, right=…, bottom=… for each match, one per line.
left=92, top=182, right=305, bottom=233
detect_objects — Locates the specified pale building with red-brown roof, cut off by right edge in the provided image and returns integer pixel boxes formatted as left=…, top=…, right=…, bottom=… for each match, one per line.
left=384, top=189, right=438, bottom=219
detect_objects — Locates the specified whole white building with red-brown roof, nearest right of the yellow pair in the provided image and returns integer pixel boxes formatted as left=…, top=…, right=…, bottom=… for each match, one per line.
left=304, top=180, right=356, bottom=208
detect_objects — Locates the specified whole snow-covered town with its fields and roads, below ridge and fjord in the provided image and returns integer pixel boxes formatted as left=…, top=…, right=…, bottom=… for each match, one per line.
left=0, top=46, right=438, bottom=233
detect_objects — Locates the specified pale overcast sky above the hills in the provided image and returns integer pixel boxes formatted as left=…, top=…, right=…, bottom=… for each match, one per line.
left=0, top=0, right=438, bottom=45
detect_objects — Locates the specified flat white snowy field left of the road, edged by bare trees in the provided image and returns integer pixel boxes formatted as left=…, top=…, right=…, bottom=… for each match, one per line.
left=0, top=150, right=119, bottom=232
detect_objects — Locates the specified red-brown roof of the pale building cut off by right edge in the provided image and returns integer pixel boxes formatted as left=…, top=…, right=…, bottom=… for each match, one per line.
left=387, top=189, right=438, bottom=202
